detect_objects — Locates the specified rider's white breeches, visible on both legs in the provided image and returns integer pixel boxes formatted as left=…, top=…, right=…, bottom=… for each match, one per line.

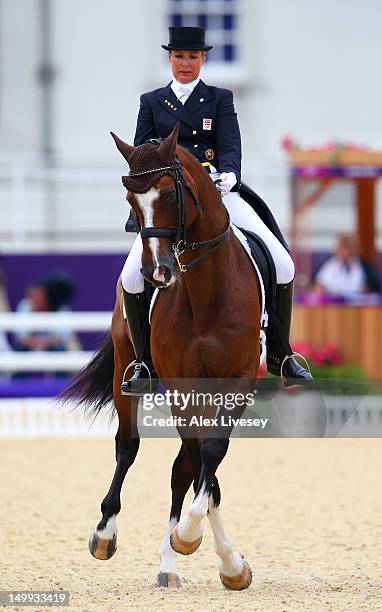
left=121, top=192, right=294, bottom=293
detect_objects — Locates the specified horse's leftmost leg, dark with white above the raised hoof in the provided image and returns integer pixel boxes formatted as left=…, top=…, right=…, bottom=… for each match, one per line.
left=89, top=359, right=139, bottom=560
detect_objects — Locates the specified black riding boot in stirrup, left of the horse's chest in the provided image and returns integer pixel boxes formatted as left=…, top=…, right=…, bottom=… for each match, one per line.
left=121, top=290, right=158, bottom=396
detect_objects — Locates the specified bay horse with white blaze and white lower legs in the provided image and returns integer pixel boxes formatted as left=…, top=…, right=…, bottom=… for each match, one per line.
left=64, top=125, right=261, bottom=590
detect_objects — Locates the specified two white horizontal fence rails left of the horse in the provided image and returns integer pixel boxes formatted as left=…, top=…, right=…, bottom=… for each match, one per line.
left=0, top=312, right=111, bottom=372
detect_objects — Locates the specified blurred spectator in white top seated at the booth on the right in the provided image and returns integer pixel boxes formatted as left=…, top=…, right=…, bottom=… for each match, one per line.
left=314, top=234, right=380, bottom=297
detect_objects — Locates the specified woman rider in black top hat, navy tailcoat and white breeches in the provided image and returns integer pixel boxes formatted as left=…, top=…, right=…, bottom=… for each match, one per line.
left=121, top=27, right=313, bottom=394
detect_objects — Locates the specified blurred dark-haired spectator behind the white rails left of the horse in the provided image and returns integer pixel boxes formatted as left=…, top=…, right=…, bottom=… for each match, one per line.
left=15, top=272, right=79, bottom=351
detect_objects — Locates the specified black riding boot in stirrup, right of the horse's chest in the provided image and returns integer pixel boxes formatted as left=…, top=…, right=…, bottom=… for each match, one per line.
left=267, top=281, right=313, bottom=387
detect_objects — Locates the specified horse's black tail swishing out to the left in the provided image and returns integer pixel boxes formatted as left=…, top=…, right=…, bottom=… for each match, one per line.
left=58, top=334, right=114, bottom=417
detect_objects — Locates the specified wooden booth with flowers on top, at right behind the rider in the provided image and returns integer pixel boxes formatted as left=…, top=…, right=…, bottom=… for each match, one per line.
left=289, top=148, right=382, bottom=379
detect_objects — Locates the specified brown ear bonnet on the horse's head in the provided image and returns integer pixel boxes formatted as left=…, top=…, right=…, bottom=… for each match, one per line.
left=111, top=122, right=180, bottom=193
